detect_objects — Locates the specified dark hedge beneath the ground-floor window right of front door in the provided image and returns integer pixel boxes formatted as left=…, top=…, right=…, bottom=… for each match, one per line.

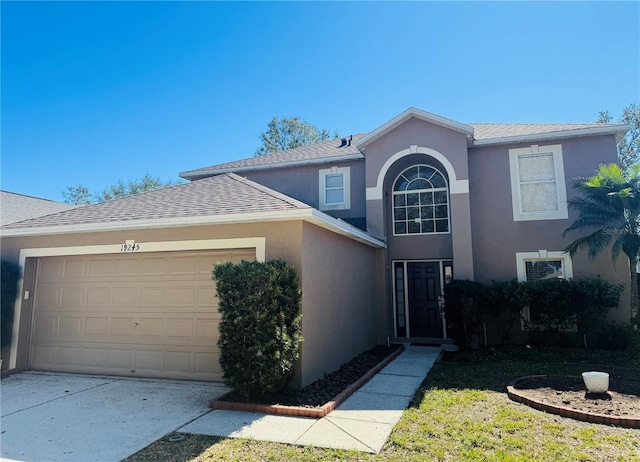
left=445, top=278, right=623, bottom=347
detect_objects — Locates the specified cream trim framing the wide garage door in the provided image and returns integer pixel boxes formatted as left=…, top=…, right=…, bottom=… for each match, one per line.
left=9, top=237, right=267, bottom=369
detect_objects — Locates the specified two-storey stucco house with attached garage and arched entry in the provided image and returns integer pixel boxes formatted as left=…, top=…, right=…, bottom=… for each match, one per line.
left=2, top=108, right=629, bottom=386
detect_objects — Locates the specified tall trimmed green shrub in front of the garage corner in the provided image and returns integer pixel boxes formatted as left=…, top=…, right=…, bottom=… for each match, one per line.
left=213, top=260, right=302, bottom=401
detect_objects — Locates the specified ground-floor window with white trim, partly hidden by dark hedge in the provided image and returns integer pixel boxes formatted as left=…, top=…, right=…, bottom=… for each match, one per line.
left=516, top=250, right=573, bottom=330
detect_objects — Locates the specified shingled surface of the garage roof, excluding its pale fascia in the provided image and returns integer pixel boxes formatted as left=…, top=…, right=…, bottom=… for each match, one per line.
left=3, top=173, right=310, bottom=229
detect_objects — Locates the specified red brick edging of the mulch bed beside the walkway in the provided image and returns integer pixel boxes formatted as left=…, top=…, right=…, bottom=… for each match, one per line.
left=209, top=345, right=404, bottom=419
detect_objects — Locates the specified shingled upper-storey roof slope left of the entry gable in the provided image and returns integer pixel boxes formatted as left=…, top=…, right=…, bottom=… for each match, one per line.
left=180, top=135, right=364, bottom=180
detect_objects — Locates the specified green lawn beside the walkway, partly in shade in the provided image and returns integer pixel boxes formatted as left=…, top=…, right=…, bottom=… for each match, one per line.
left=122, top=348, right=640, bottom=462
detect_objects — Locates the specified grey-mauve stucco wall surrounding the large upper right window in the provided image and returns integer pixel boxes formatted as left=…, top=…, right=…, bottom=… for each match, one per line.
left=470, top=135, right=629, bottom=321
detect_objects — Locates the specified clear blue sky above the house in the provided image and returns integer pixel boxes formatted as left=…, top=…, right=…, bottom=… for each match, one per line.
left=0, top=1, right=640, bottom=200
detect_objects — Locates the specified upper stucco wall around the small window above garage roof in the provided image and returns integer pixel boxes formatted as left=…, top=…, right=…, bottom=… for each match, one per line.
left=242, top=159, right=366, bottom=222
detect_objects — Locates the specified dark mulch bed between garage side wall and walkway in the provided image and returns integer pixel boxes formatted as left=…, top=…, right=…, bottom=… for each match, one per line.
left=221, top=345, right=402, bottom=408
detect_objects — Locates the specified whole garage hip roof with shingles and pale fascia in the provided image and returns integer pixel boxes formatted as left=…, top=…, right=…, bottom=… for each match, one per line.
left=0, top=173, right=385, bottom=248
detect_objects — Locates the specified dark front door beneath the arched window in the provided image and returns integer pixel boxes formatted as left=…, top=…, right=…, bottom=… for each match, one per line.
left=407, top=262, right=442, bottom=338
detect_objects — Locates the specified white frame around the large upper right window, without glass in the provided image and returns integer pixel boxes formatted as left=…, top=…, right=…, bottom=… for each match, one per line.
left=509, top=144, right=569, bottom=221
